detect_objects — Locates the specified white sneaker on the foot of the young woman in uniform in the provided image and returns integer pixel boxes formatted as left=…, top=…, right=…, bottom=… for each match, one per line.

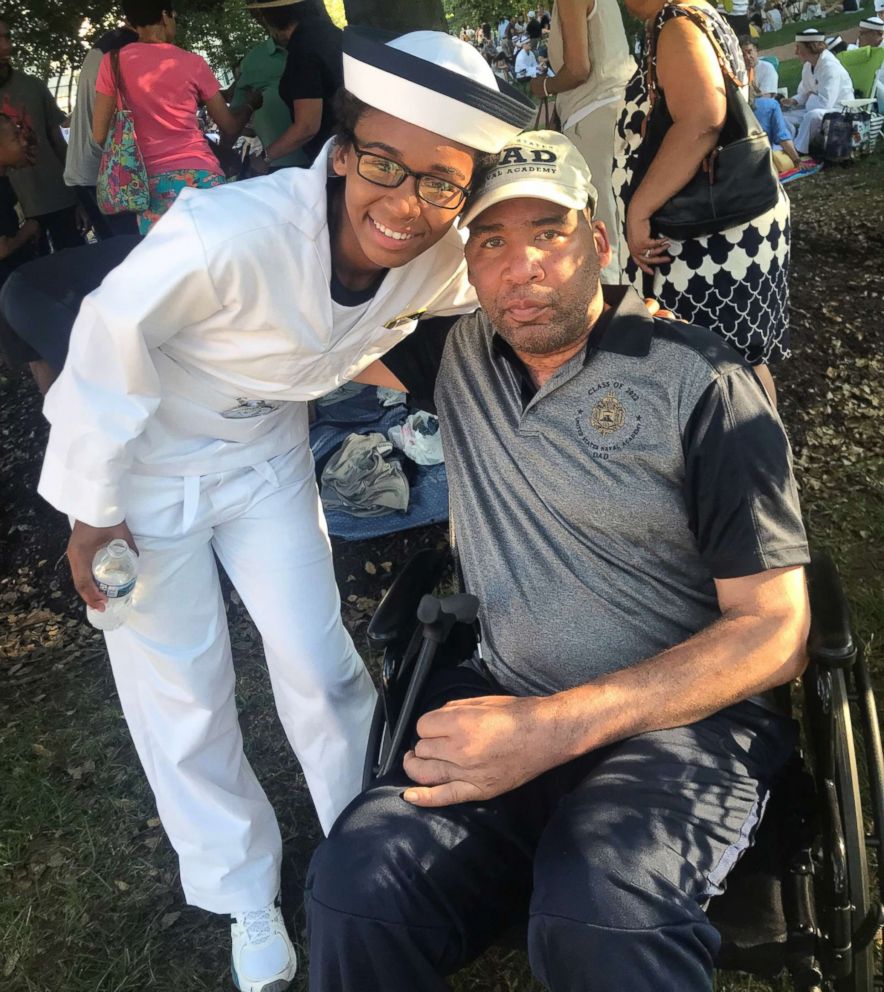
left=230, top=903, right=298, bottom=992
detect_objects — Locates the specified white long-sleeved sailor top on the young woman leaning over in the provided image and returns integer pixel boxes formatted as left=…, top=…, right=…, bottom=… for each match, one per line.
left=39, top=146, right=477, bottom=527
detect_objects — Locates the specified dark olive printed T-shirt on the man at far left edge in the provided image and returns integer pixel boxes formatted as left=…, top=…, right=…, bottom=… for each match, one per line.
left=0, top=69, right=77, bottom=217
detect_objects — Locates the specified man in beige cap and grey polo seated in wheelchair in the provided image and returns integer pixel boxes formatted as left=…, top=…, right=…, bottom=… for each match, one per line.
left=307, top=132, right=809, bottom=992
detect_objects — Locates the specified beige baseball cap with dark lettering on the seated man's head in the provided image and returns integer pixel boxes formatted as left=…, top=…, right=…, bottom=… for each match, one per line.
left=460, top=131, right=598, bottom=227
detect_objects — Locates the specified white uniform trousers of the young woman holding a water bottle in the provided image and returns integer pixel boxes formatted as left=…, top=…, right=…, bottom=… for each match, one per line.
left=106, top=445, right=375, bottom=913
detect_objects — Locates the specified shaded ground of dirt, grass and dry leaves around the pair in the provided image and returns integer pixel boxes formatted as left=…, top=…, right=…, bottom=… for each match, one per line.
left=0, top=153, right=884, bottom=992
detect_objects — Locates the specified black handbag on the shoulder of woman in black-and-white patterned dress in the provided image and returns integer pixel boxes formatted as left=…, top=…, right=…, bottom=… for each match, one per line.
left=632, top=6, right=780, bottom=241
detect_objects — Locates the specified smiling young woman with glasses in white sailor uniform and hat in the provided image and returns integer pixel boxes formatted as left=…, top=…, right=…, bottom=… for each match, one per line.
left=40, top=30, right=533, bottom=992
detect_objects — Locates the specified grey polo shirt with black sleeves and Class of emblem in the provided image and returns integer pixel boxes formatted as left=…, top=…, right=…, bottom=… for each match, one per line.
left=384, top=287, right=809, bottom=694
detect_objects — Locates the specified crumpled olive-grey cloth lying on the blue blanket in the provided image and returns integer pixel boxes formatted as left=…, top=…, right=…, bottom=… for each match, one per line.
left=320, top=434, right=409, bottom=517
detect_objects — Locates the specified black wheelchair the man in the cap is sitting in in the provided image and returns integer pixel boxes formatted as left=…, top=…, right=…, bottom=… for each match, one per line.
left=363, top=549, right=884, bottom=992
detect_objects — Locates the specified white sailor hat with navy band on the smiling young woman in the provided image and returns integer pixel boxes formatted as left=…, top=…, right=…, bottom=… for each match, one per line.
left=344, top=27, right=535, bottom=152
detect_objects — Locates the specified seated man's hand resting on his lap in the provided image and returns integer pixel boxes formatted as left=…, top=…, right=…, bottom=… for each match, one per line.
left=404, top=696, right=563, bottom=806
